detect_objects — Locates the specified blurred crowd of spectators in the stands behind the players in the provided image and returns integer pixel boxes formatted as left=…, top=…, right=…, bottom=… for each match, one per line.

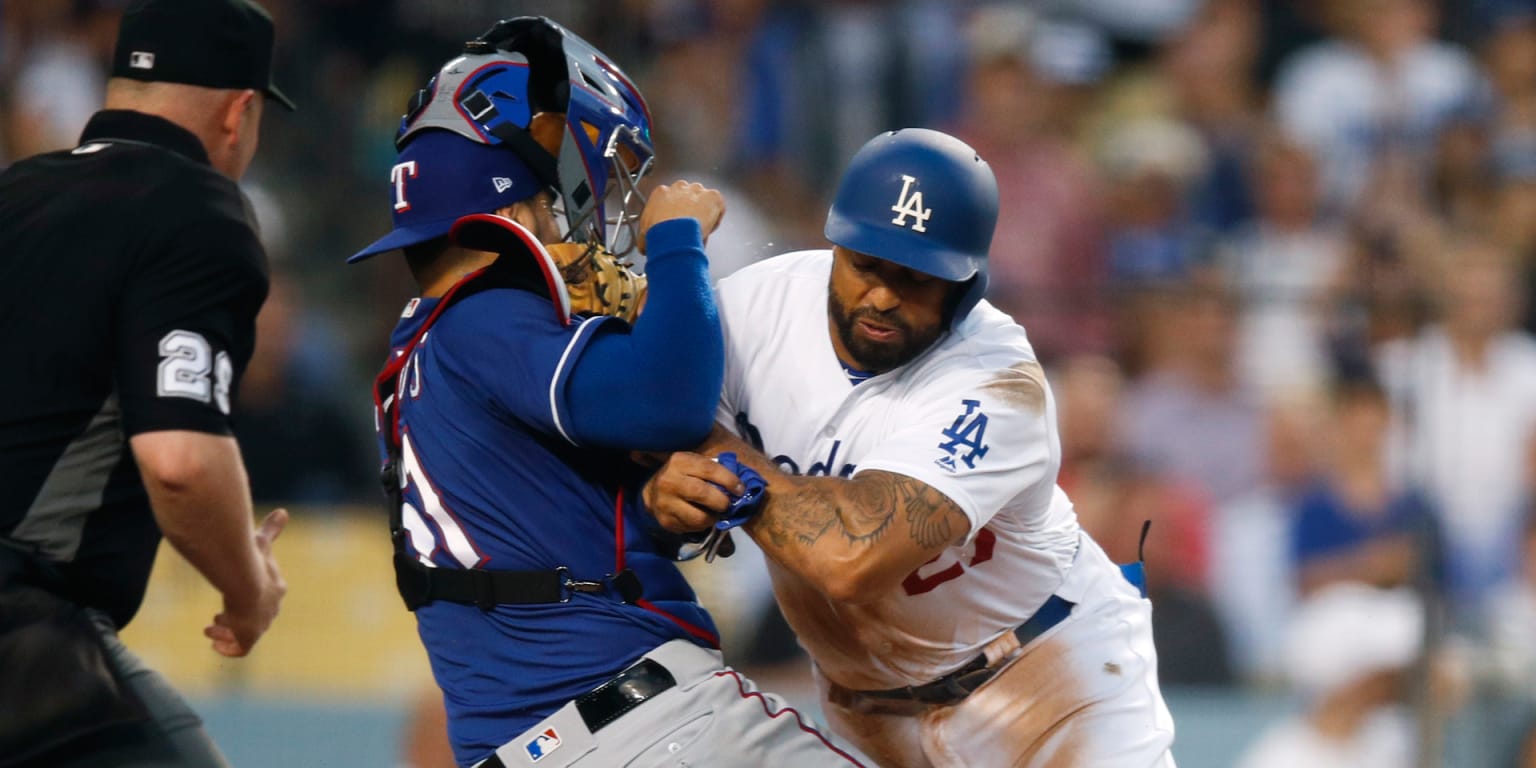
left=9, top=0, right=1536, bottom=765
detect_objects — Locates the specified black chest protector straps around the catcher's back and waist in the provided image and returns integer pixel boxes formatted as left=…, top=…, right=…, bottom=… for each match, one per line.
left=373, top=260, right=644, bottom=610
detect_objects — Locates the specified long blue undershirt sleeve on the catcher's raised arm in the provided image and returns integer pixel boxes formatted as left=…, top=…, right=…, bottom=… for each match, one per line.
left=565, top=218, right=725, bottom=450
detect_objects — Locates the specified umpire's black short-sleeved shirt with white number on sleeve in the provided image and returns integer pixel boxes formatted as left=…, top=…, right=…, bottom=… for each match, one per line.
left=0, top=111, right=267, bottom=627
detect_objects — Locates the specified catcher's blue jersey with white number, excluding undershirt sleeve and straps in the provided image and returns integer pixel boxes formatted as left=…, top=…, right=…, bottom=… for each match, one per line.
left=381, top=289, right=717, bottom=765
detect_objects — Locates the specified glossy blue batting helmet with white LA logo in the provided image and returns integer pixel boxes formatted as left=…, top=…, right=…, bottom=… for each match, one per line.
left=826, top=127, right=997, bottom=323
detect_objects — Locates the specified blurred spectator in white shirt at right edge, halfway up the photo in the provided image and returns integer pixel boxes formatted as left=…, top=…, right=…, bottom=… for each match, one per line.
left=1378, top=240, right=1536, bottom=621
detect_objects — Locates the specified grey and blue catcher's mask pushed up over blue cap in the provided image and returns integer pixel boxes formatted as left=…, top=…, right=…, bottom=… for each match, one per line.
left=395, top=17, right=653, bottom=253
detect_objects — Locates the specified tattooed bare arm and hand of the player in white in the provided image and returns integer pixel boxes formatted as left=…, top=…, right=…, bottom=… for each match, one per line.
left=645, top=427, right=971, bottom=602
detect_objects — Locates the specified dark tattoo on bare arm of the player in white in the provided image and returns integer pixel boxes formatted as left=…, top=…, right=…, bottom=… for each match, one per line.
left=760, top=470, right=960, bottom=548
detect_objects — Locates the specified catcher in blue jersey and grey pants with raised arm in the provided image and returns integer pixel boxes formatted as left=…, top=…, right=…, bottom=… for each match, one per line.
left=349, top=17, right=859, bottom=768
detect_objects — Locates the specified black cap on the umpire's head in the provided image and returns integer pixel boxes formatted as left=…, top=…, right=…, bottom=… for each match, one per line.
left=112, top=0, right=293, bottom=111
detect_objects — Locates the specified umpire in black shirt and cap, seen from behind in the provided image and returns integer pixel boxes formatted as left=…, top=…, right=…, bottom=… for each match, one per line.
left=0, top=0, right=293, bottom=766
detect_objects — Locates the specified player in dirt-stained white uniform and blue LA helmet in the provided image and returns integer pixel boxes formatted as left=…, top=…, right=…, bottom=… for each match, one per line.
left=644, top=129, right=1174, bottom=768
